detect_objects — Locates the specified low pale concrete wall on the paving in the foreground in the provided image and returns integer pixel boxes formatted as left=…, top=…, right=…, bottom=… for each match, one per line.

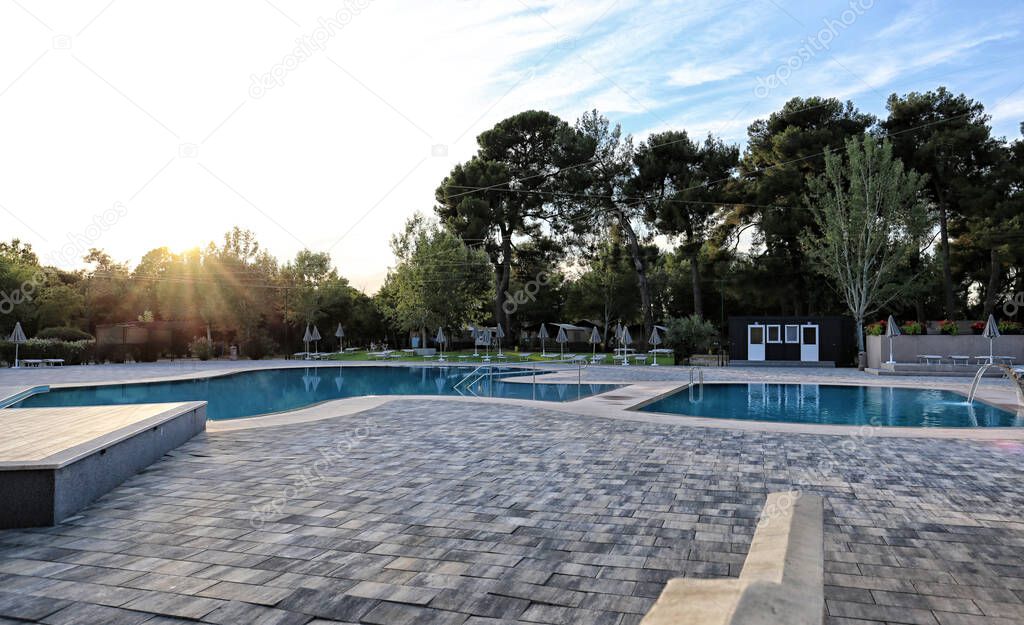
left=641, top=492, right=824, bottom=625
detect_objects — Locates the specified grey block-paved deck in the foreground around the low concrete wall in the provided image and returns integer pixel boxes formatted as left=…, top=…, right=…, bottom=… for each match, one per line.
left=0, top=401, right=1024, bottom=625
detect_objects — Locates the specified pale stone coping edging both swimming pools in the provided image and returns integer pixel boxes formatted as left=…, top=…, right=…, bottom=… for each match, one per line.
left=6, top=361, right=1024, bottom=441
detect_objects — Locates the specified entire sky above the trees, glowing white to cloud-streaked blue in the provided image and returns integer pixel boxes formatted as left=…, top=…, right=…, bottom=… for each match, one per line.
left=0, top=0, right=1024, bottom=293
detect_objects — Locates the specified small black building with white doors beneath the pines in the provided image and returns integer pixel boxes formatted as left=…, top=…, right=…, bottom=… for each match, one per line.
left=729, top=316, right=857, bottom=367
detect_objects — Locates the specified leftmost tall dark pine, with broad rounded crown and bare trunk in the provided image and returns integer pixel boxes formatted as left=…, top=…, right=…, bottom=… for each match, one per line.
left=435, top=111, right=591, bottom=328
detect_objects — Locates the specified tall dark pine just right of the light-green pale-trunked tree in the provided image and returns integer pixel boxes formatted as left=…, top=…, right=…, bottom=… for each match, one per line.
left=882, top=87, right=995, bottom=319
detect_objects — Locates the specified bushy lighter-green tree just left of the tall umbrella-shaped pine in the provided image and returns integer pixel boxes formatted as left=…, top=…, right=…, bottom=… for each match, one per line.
left=380, top=213, right=492, bottom=345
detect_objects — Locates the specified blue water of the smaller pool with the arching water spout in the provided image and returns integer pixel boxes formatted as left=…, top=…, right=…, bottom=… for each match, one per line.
left=641, top=384, right=1024, bottom=427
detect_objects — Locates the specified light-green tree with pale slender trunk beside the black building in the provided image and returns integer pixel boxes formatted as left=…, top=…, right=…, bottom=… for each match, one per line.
left=803, top=135, right=931, bottom=351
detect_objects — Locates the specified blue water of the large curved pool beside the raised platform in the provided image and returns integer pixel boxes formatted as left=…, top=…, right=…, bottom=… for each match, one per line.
left=14, top=367, right=617, bottom=419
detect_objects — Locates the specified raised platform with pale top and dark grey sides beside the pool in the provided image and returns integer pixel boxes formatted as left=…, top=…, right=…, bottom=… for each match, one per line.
left=0, top=402, right=206, bottom=529
